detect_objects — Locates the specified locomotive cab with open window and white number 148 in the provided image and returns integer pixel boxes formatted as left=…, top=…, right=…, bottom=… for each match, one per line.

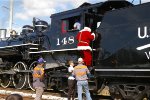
left=44, top=1, right=132, bottom=67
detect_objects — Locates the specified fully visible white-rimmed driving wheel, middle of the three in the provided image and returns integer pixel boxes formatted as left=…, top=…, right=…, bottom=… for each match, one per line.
left=12, top=62, right=27, bottom=89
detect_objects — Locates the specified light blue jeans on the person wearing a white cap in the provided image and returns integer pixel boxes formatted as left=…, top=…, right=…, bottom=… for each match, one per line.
left=77, top=80, right=92, bottom=100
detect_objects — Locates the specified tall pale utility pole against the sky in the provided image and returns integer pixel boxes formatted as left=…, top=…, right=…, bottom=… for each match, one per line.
left=9, top=0, right=14, bottom=31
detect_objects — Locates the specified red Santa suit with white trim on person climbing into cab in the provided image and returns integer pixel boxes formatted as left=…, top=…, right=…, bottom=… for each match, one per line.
left=76, top=27, right=95, bottom=66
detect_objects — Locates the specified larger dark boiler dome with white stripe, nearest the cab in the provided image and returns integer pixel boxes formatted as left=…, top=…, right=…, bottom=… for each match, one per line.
left=35, top=20, right=48, bottom=32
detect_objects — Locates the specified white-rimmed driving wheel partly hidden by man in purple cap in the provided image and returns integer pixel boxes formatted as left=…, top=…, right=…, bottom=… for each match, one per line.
left=28, top=61, right=37, bottom=91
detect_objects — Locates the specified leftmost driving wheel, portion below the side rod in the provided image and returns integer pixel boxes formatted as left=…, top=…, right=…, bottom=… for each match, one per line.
left=0, top=74, right=12, bottom=88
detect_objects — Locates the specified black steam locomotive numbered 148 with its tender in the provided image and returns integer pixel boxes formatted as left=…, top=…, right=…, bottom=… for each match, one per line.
left=0, top=0, right=150, bottom=100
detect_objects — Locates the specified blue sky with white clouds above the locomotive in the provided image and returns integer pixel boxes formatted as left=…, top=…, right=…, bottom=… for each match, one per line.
left=0, top=0, right=150, bottom=35
